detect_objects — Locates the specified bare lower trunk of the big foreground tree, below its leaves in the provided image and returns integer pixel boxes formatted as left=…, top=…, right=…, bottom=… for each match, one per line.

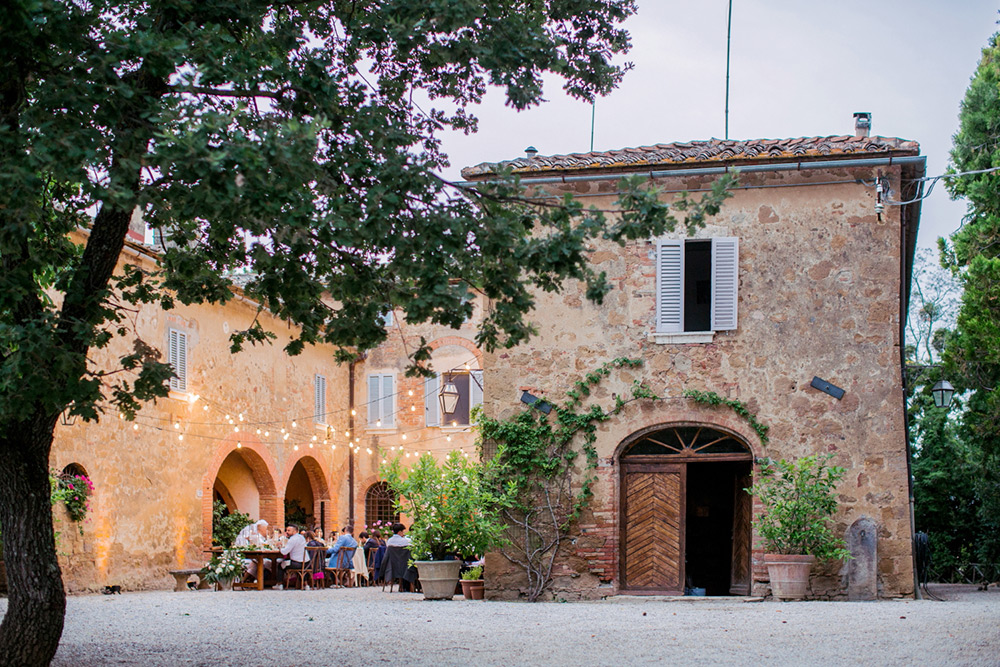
left=0, top=416, right=66, bottom=665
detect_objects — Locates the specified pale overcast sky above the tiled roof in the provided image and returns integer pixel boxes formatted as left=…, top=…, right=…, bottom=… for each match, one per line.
left=445, top=0, right=998, bottom=247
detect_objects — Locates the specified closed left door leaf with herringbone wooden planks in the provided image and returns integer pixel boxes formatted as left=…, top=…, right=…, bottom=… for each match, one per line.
left=621, top=464, right=686, bottom=595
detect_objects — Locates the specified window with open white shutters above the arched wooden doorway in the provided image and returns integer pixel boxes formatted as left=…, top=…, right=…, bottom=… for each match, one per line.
left=656, top=237, right=739, bottom=333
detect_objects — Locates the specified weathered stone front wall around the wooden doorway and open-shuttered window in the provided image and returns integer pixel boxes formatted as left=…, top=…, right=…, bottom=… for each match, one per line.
left=485, top=168, right=913, bottom=598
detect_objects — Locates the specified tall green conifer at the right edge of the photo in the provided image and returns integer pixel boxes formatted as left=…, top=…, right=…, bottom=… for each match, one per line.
left=939, top=35, right=1000, bottom=563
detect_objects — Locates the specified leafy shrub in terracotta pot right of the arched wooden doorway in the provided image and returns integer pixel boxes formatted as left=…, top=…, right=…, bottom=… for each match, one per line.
left=747, top=454, right=851, bottom=600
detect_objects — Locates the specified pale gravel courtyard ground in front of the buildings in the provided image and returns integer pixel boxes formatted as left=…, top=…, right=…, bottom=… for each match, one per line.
left=0, top=587, right=1000, bottom=667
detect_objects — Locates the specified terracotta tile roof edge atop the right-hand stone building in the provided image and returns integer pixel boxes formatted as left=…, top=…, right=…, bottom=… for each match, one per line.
left=462, top=135, right=920, bottom=178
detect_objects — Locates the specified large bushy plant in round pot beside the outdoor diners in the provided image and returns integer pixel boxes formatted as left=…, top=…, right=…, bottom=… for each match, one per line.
left=381, top=451, right=504, bottom=600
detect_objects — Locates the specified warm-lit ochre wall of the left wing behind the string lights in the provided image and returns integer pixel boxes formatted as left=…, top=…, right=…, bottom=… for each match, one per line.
left=51, top=239, right=480, bottom=591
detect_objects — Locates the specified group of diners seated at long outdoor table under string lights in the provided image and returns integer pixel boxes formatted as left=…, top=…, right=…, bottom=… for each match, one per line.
left=233, top=519, right=410, bottom=587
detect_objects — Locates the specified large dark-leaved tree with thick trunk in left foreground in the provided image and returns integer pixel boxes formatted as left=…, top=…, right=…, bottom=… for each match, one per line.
left=0, top=0, right=736, bottom=664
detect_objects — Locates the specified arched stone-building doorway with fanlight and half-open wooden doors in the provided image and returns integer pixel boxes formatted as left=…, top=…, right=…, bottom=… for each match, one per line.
left=619, top=423, right=753, bottom=595
